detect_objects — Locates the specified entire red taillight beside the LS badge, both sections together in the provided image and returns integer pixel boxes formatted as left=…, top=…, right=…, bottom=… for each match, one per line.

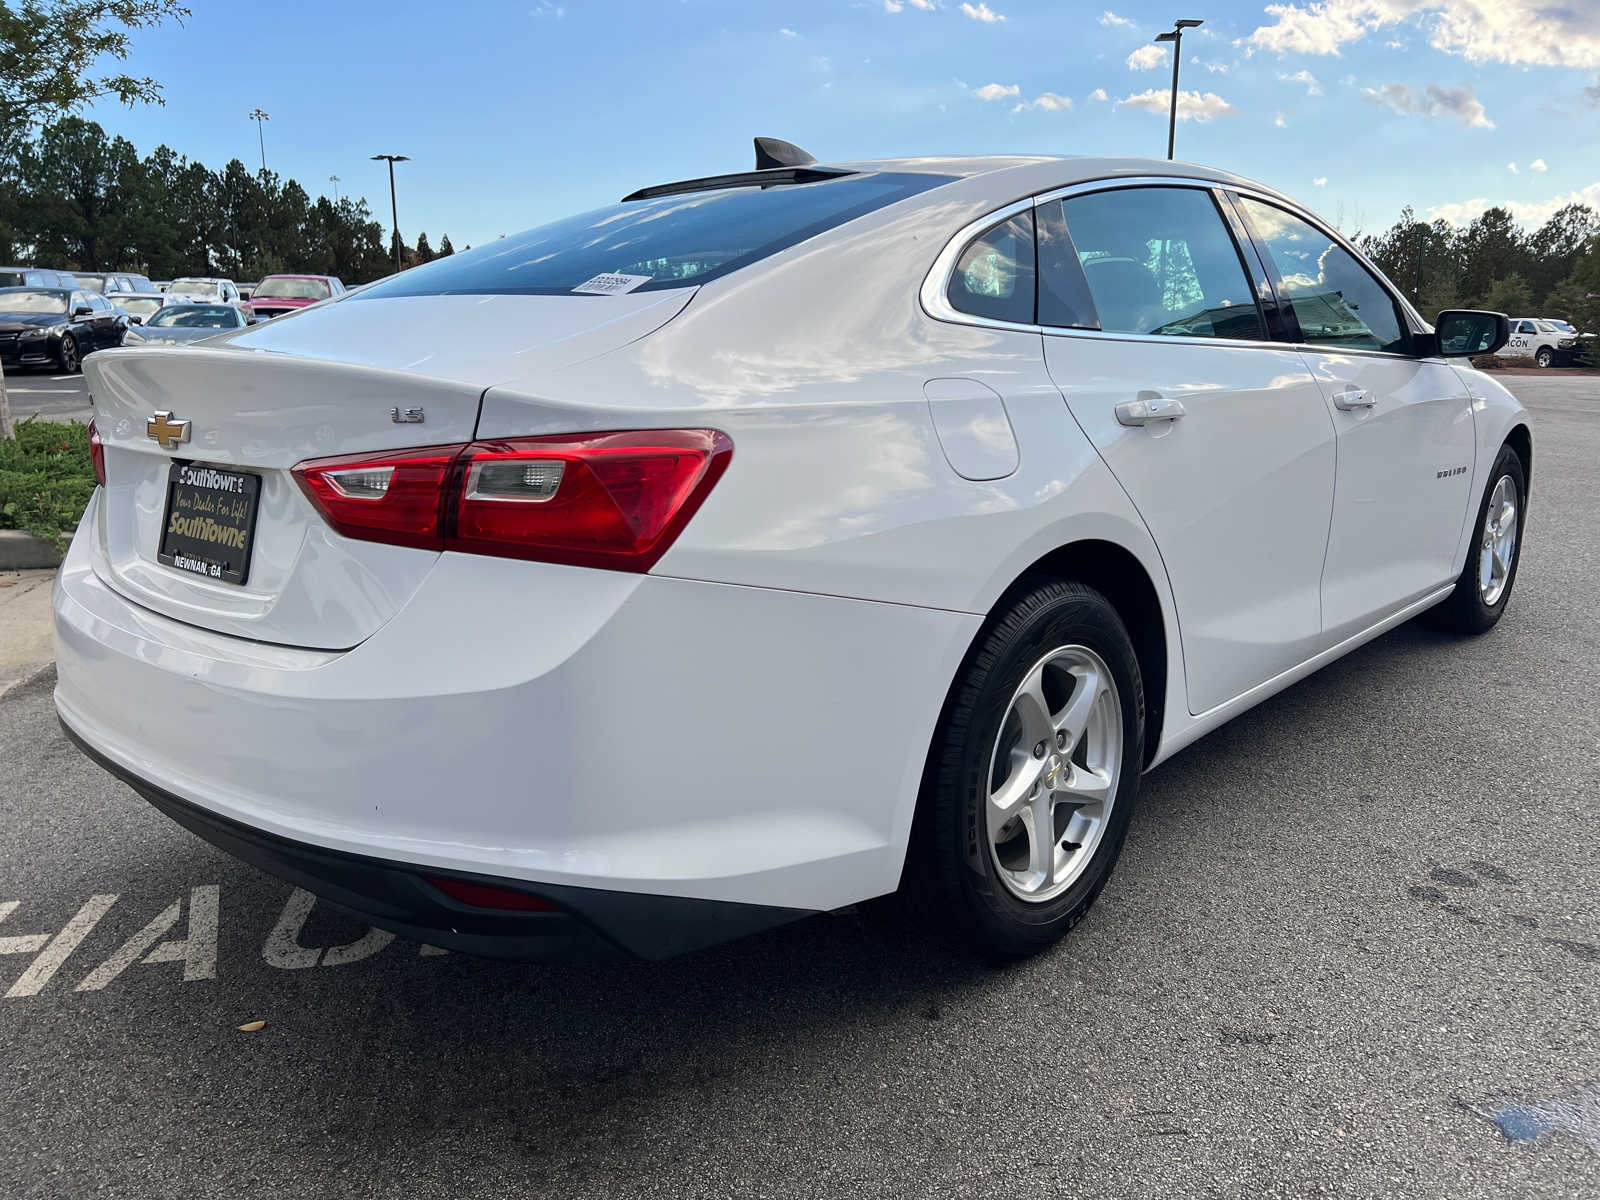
left=294, top=429, right=733, bottom=571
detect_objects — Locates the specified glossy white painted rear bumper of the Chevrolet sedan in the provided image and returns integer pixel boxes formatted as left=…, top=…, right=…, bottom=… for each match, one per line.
left=54, top=496, right=981, bottom=957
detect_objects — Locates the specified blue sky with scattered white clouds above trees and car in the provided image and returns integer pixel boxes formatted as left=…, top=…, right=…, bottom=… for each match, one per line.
left=78, top=0, right=1600, bottom=248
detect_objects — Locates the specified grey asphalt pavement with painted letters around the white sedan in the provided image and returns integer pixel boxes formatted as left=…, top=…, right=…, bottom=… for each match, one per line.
left=0, top=378, right=1600, bottom=1200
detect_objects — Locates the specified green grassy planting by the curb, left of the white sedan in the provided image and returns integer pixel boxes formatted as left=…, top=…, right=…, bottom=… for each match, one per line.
left=0, top=418, right=94, bottom=550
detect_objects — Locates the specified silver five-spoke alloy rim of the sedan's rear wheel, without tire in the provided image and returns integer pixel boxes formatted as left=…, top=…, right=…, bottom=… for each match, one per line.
left=984, top=645, right=1123, bottom=902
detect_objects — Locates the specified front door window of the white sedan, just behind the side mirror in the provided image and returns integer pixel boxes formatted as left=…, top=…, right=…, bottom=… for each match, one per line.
left=1240, top=197, right=1406, bottom=354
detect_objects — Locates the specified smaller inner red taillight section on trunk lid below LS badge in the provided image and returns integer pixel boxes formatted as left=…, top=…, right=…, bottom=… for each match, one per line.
left=294, top=446, right=462, bottom=550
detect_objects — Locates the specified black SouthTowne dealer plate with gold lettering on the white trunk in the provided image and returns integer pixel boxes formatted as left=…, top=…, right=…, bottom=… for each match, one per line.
left=155, top=462, right=261, bottom=584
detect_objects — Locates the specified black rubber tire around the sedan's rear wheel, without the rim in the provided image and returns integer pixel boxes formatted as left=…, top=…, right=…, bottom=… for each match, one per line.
left=898, top=578, right=1144, bottom=962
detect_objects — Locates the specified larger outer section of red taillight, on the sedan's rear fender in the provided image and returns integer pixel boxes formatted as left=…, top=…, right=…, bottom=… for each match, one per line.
left=446, top=429, right=733, bottom=571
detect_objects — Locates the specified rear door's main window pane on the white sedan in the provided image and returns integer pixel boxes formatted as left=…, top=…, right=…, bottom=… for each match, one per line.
left=1061, top=187, right=1266, bottom=341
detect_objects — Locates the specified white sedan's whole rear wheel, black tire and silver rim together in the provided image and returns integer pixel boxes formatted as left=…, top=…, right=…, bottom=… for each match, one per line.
left=899, top=579, right=1144, bottom=962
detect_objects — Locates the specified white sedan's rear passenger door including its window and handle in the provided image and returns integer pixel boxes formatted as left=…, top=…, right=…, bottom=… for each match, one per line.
left=1038, top=186, right=1334, bottom=712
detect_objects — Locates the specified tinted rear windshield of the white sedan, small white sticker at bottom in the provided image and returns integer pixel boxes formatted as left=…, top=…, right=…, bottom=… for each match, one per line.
left=358, top=174, right=949, bottom=299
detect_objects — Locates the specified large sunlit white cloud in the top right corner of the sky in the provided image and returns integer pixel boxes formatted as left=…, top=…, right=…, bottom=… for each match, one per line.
left=1243, top=0, right=1600, bottom=67
